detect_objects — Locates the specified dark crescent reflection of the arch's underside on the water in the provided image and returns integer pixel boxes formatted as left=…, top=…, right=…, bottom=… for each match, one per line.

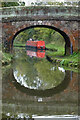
left=12, top=71, right=70, bottom=97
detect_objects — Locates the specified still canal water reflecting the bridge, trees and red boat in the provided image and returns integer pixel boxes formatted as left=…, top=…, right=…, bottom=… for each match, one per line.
left=2, top=48, right=78, bottom=118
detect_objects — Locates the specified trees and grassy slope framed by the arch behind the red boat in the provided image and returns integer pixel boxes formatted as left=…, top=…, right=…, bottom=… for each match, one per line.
left=14, top=27, right=65, bottom=55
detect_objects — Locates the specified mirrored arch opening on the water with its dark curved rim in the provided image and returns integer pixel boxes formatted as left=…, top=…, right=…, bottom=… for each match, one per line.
left=13, top=49, right=70, bottom=96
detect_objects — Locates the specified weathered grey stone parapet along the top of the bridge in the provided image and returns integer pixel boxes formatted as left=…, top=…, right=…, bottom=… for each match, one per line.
left=0, top=6, right=79, bottom=22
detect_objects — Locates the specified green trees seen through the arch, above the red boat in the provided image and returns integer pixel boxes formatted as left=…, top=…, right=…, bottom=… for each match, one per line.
left=14, top=27, right=64, bottom=44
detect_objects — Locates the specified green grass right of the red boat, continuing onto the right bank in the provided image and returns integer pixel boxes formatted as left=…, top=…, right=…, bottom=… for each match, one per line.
left=46, top=44, right=80, bottom=69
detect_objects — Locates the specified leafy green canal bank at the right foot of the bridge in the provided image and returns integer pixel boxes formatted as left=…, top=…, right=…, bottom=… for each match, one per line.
left=47, top=52, right=80, bottom=69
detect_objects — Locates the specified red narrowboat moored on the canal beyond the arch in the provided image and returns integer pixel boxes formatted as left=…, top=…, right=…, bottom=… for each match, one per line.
left=26, top=40, right=45, bottom=49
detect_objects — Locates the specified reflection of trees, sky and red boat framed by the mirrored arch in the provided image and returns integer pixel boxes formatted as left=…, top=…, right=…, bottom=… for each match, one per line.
left=13, top=47, right=65, bottom=90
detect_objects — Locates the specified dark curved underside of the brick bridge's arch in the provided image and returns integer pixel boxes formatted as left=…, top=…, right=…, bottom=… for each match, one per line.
left=11, top=25, right=73, bottom=55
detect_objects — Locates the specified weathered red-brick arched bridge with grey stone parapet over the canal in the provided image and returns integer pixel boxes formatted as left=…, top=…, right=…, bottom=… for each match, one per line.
left=0, top=6, right=80, bottom=55
